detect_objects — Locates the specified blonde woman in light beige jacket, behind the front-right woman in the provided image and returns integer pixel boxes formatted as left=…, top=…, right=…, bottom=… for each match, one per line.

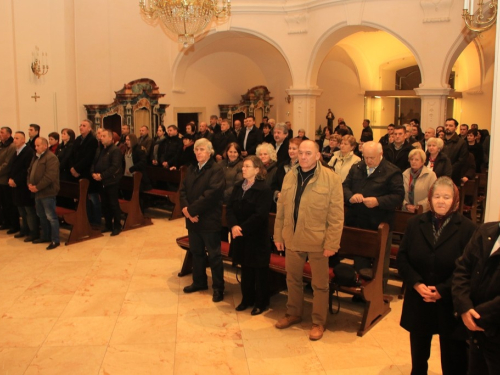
left=403, top=149, right=436, bottom=212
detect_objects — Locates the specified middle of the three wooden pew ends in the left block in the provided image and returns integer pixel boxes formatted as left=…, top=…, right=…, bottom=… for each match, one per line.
left=119, top=172, right=153, bottom=230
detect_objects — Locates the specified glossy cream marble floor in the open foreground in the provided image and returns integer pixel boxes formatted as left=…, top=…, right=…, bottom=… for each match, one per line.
left=0, top=215, right=441, bottom=375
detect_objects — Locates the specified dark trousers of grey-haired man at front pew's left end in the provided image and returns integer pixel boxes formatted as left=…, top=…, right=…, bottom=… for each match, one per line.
left=188, top=230, right=224, bottom=292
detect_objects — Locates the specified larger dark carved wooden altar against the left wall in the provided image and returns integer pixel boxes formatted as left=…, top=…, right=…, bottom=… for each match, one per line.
left=85, top=78, right=169, bottom=135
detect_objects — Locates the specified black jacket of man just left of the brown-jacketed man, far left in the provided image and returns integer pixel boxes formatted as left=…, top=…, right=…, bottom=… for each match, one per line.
left=9, top=145, right=35, bottom=206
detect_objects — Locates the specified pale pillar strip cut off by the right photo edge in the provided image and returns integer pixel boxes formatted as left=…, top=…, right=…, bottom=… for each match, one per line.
left=484, top=25, right=500, bottom=222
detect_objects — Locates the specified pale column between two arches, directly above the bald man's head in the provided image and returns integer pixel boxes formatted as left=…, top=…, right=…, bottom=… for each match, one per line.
left=286, top=86, right=323, bottom=140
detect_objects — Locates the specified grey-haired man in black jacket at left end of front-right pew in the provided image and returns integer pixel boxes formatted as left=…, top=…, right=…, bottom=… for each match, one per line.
left=180, top=139, right=225, bottom=302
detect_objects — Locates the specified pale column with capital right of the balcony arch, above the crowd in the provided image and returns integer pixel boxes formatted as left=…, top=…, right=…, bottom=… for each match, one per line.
left=415, top=88, right=451, bottom=131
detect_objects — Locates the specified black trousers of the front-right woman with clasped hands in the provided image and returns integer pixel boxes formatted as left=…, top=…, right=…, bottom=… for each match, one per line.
left=410, top=333, right=467, bottom=375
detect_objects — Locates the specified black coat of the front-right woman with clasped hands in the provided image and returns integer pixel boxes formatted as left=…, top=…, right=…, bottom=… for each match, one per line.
left=397, top=211, right=476, bottom=338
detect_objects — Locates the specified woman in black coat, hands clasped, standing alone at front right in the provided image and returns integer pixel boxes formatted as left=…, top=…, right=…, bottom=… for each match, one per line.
left=397, top=177, right=475, bottom=375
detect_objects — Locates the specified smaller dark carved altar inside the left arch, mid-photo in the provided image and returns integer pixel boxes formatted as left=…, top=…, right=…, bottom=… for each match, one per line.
left=219, top=86, right=273, bottom=124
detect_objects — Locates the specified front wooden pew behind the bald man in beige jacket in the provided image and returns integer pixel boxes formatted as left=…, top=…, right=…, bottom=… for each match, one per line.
left=177, top=212, right=391, bottom=336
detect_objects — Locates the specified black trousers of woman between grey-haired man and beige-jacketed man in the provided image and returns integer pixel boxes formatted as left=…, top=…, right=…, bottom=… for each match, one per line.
left=241, top=266, right=269, bottom=309
